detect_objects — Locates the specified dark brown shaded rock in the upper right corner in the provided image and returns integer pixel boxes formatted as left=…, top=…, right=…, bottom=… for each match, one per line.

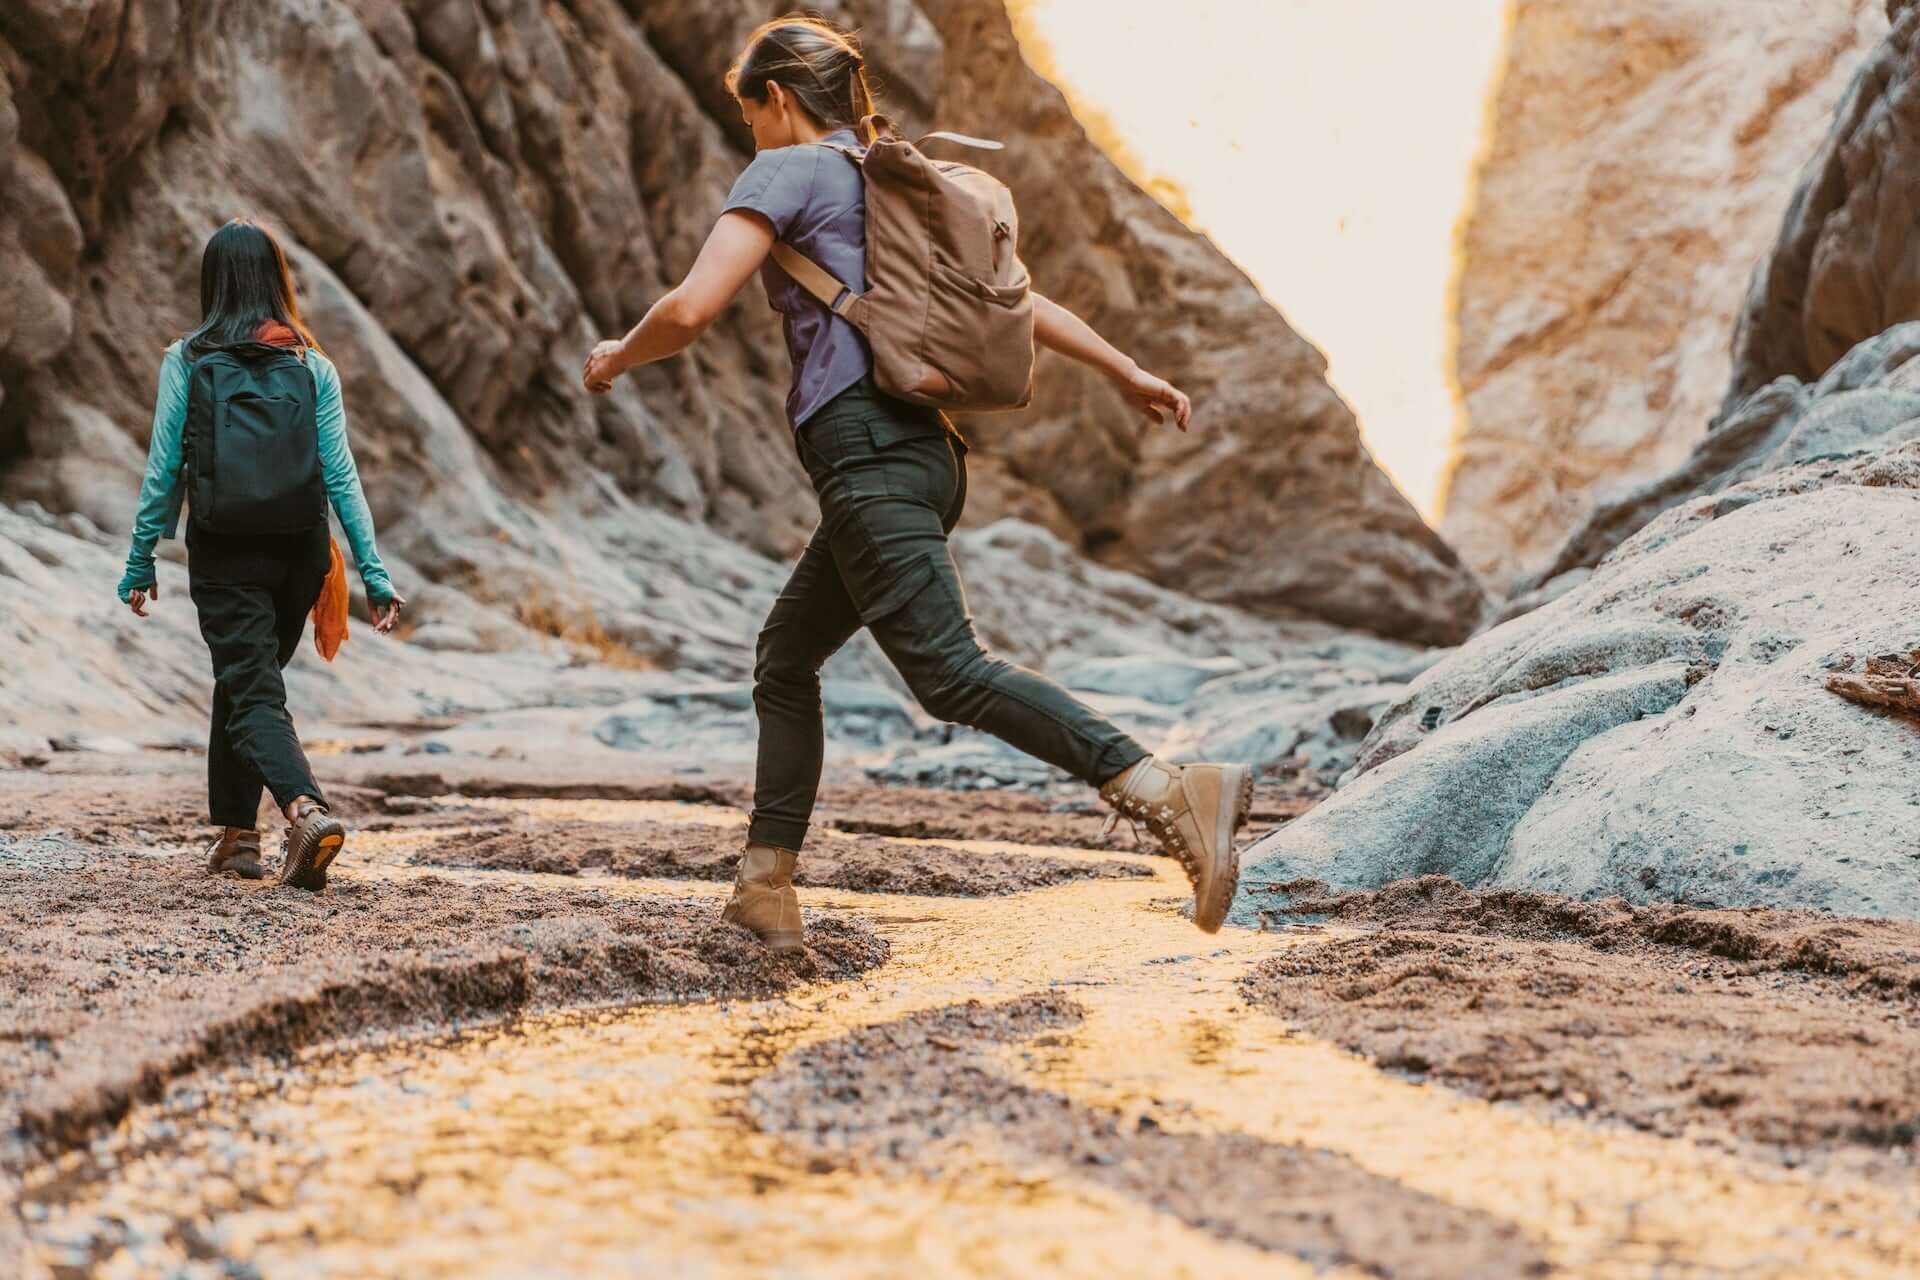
left=1726, top=0, right=1920, bottom=411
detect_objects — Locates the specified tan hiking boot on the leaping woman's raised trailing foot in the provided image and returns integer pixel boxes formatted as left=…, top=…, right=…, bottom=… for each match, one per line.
left=1100, top=756, right=1254, bottom=933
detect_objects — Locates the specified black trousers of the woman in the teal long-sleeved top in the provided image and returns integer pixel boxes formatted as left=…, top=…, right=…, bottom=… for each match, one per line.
left=186, top=524, right=330, bottom=827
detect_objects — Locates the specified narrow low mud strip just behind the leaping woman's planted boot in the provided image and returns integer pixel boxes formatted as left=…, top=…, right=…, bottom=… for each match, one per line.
left=409, top=821, right=1152, bottom=898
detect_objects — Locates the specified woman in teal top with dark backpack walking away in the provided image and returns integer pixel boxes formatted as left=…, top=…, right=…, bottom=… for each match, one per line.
left=119, top=219, right=405, bottom=890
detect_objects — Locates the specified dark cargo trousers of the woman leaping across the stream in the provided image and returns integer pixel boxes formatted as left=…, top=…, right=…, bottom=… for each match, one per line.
left=749, top=380, right=1146, bottom=850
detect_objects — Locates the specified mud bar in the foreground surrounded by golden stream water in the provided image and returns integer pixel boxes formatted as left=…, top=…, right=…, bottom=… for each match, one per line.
left=751, top=994, right=1548, bottom=1280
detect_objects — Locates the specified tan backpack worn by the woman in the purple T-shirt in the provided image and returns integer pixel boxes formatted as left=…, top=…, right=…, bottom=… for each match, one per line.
left=774, top=115, right=1033, bottom=413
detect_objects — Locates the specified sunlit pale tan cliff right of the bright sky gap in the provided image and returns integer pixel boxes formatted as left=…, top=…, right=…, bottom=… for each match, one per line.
left=1440, top=0, right=1881, bottom=587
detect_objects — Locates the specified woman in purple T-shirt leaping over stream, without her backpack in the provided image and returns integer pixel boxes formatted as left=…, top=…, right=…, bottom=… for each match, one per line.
left=584, top=17, right=1252, bottom=950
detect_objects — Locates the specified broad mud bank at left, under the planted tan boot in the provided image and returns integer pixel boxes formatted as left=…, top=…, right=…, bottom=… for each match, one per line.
left=0, top=837, right=887, bottom=1150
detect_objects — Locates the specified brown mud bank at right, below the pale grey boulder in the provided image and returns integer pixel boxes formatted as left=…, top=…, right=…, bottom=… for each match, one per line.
left=1242, top=877, right=1920, bottom=1176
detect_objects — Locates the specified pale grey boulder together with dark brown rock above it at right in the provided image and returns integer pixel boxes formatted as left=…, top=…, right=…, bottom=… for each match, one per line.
left=1240, top=0, right=1920, bottom=921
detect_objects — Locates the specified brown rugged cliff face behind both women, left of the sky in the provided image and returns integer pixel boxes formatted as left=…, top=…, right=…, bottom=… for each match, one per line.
left=0, top=0, right=1482, bottom=662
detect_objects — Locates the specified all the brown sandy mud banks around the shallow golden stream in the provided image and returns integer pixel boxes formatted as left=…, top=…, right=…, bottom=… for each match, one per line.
left=11, top=752, right=1920, bottom=1276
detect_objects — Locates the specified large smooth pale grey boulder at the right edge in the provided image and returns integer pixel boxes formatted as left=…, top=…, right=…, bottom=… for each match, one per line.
left=1246, top=324, right=1920, bottom=917
